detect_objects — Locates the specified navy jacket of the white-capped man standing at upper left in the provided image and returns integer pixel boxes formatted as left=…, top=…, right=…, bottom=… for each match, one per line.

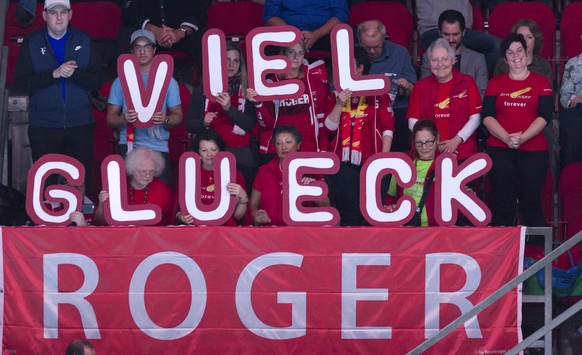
left=15, top=26, right=103, bottom=128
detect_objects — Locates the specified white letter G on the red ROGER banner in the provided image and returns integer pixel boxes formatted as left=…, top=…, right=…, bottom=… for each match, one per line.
left=235, top=253, right=307, bottom=340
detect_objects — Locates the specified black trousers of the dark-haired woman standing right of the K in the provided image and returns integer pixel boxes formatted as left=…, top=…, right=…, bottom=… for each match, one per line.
left=487, top=147, right=549, bottom=227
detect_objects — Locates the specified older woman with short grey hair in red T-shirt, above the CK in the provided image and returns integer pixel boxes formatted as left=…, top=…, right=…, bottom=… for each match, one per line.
left=407, top=38, right=482, bottom=161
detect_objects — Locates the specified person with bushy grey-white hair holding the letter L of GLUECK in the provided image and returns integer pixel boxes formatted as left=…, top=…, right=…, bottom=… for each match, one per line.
left=93, top=147, right=174, bottom=226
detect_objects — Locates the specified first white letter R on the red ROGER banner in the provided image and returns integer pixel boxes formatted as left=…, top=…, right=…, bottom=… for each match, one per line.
left=42, top=253, right=101, bottom=339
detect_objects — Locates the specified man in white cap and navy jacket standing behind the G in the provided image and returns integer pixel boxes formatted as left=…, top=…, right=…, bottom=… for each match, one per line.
left=15, top=0, right=103, bottom=195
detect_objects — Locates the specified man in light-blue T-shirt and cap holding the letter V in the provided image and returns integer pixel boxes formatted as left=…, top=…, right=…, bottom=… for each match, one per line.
left=107, top=30, right=182, bottom=186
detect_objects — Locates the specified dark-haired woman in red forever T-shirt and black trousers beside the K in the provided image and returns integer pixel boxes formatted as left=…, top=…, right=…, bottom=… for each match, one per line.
left=482, top=33, right=554, bottom=227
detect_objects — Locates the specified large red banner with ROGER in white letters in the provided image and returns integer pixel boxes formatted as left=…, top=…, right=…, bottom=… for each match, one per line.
left=0, top=227, right=524, bottom=354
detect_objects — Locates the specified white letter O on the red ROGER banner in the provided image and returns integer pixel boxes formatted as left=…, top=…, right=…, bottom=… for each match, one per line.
left=129, top=252, right=206, bottom=340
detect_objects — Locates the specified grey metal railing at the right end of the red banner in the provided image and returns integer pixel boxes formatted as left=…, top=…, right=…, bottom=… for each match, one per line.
left=409, top=227, right=582, bottom=354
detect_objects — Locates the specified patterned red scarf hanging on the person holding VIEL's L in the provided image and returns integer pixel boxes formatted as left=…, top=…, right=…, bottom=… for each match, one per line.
left=340, top=96, right=368, bottom=165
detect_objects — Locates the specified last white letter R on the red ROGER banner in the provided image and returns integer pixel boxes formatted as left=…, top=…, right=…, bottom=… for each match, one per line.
left=424, top=253, right=483, bottom=339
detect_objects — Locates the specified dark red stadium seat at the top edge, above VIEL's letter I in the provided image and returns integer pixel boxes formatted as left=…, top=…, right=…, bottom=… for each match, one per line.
left=208, top=1, right=264, bottom=40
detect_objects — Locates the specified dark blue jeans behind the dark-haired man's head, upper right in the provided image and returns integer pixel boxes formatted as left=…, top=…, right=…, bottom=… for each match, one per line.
left=420, top=28, right=501, bottom=75
